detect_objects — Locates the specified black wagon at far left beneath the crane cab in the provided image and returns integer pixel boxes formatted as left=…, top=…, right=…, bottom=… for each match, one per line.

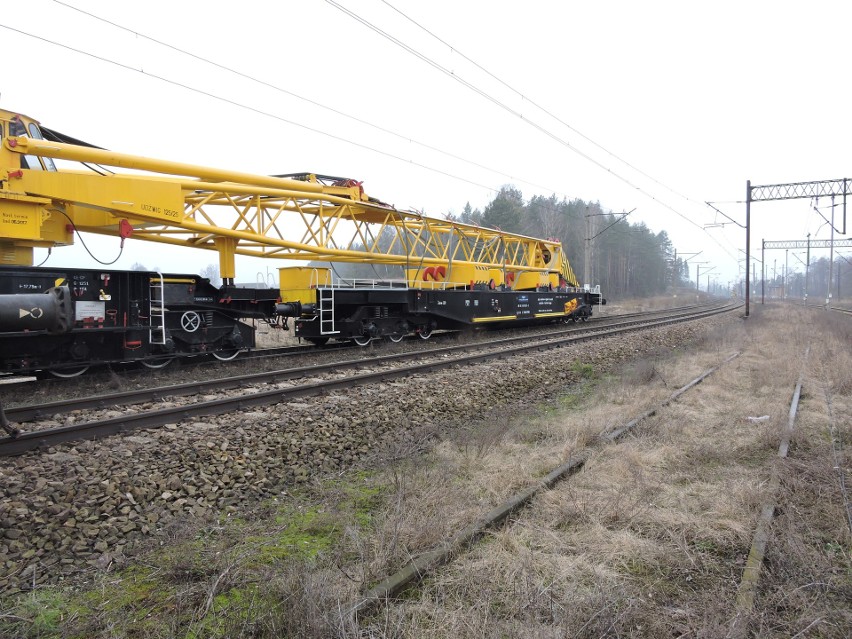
left=0, top=266, right=278, bottom=377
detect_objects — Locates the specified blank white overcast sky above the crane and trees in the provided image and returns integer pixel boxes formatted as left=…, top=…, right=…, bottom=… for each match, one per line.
left=0, top=0, right=852, bottom=287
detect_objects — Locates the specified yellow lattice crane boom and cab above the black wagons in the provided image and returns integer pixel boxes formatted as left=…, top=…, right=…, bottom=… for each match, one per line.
left=0, top=111, right=578, bottom=286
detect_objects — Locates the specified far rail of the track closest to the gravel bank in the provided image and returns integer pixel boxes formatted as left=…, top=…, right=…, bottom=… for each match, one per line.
left=6, top=304, right=728, bottom=423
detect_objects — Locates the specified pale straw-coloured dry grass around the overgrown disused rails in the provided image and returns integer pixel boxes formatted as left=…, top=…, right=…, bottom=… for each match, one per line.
left=350, top=309, right=852, bottom=637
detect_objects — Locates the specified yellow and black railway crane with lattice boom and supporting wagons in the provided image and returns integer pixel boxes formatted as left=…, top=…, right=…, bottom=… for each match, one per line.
left=0, top=110, right=606, bottom=376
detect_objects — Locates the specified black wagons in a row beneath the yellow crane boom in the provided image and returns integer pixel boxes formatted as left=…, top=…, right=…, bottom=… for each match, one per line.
left=0, top=266, right=606, bottom=377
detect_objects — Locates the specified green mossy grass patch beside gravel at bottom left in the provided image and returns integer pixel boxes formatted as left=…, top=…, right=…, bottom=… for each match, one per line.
left=0, top=473, right=387, bottom=639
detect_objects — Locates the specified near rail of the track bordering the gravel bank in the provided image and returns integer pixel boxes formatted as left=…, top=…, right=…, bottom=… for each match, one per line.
left=0, top=305, right=738, bottom=456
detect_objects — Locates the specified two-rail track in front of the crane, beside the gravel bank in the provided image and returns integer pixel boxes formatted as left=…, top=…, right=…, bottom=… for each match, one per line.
left=0, top=304, right=737, bottom=456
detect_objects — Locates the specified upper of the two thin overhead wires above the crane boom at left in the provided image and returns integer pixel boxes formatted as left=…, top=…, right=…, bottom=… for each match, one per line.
left=48, top=0, right=569, bottom=197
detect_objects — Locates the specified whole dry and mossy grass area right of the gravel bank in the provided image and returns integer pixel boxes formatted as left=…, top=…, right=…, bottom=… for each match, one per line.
left=0, top=307, right=852, bottom=639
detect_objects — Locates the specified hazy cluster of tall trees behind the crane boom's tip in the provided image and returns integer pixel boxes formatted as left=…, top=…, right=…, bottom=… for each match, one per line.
left=449, top=186, right=676, bottom=297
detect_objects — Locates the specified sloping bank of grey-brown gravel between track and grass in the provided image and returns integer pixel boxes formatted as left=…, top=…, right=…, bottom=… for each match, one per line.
left=0, top=314, right=735, bottom=593
